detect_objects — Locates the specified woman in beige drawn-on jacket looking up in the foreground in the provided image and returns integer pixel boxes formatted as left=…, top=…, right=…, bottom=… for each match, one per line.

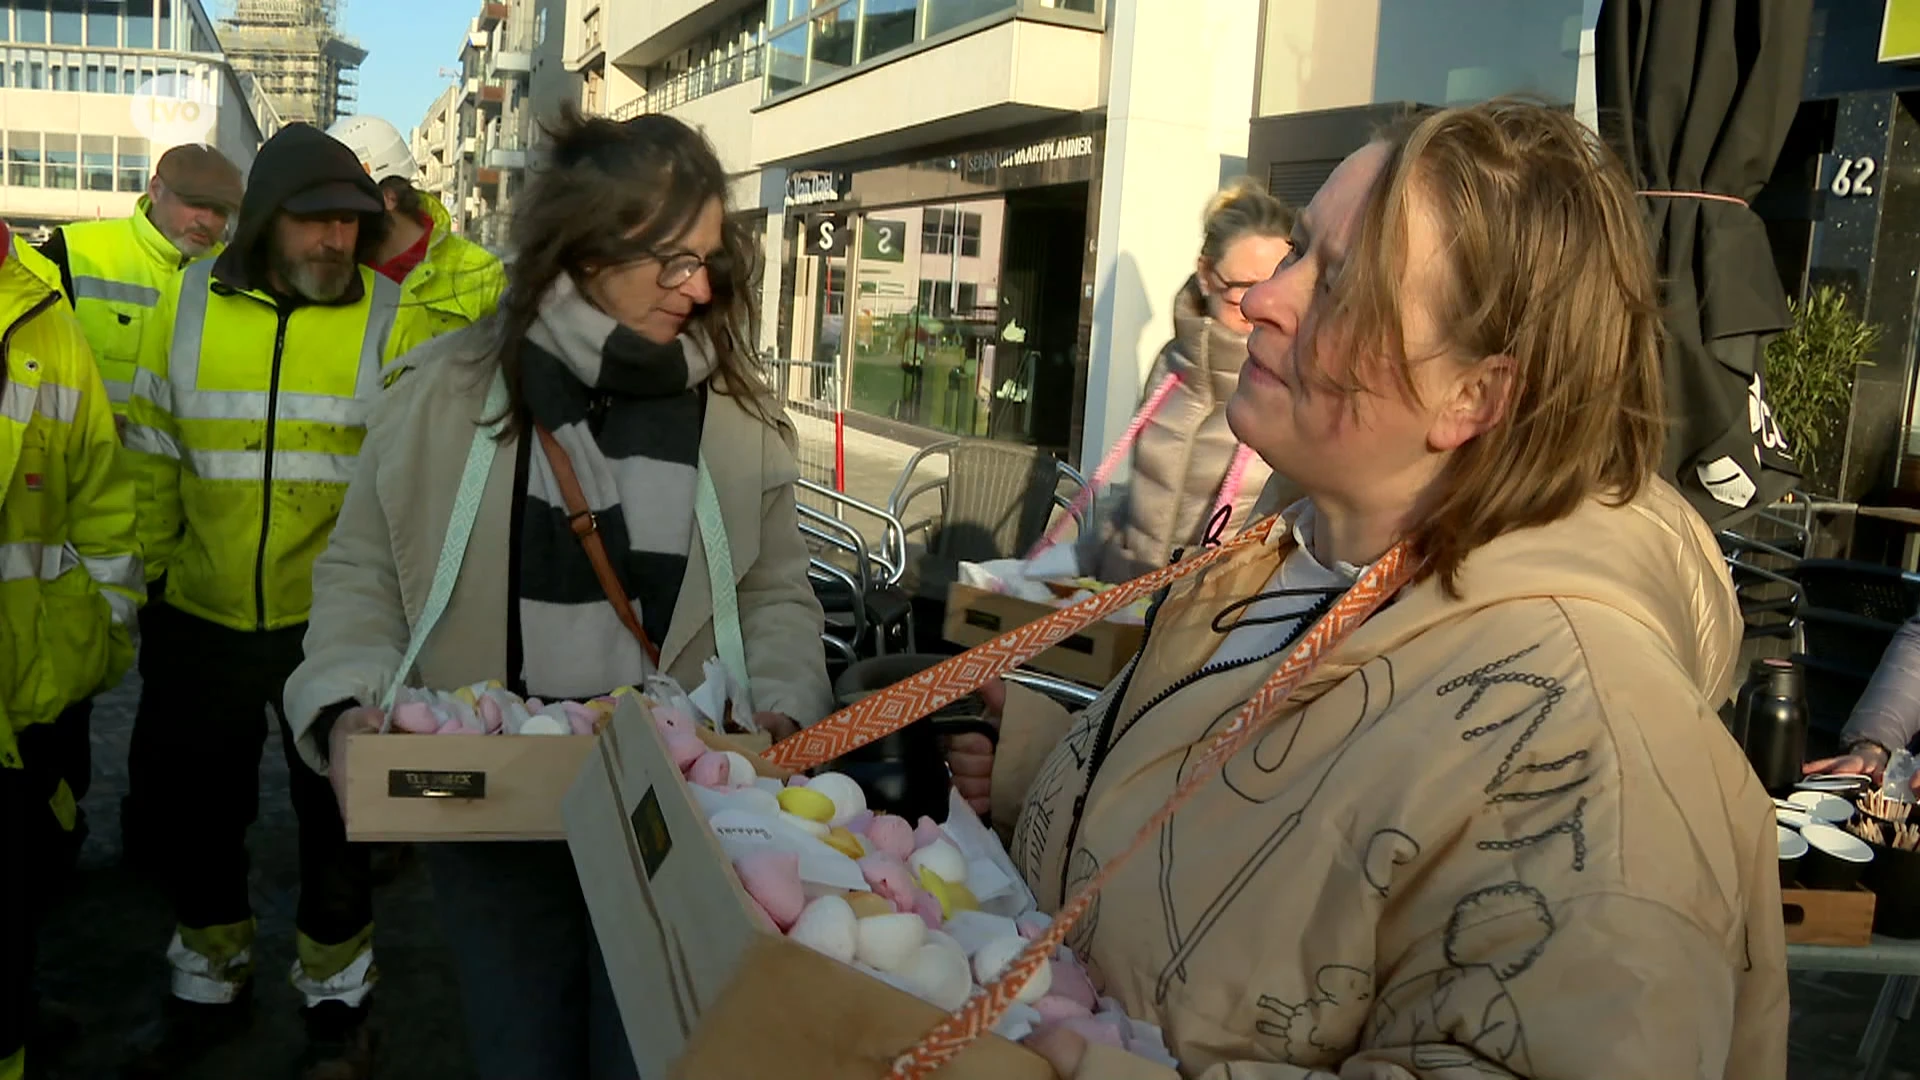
left=952, top=104, right=1788, bottom=1080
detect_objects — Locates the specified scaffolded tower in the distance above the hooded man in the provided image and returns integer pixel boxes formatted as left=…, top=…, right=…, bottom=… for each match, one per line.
left=219, top=0, right=367, bottom=127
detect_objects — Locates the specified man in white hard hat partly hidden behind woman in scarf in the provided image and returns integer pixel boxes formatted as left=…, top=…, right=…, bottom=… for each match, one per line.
left=326, top=115, right=507, bottom=373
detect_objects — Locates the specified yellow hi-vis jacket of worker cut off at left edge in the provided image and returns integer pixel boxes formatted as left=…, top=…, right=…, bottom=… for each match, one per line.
left=0, top=240, right=146, bottom=769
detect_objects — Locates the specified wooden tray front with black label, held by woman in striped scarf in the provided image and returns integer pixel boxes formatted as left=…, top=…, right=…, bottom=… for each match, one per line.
left=346, top=734, right=595, bottom=842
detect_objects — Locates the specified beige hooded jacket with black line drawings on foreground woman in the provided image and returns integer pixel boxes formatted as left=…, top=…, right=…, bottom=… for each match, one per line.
left=993, top=484, right=1788, bottom=1080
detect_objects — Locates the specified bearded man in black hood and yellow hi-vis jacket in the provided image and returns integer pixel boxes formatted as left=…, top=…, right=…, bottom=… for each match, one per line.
left=123, top=125, right=399, bottom=1080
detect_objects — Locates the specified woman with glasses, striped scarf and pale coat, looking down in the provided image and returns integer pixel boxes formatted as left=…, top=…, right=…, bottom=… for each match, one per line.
left=286, top=111, right=833, bottom=1080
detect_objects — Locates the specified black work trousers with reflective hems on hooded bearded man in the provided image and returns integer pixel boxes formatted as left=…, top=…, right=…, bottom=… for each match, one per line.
left=129, top=605, right=374, bottom=1007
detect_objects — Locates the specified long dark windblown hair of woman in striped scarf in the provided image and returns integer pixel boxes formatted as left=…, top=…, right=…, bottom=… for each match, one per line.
left=493, top=104, right=776, bottom=434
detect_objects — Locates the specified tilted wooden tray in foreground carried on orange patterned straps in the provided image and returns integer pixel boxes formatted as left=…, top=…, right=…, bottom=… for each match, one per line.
left=563, top=700, right=1054, bottom=1080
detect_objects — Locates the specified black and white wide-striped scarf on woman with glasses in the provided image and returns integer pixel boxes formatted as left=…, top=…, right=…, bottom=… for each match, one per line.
left=518, top=275, right=714, bottom=698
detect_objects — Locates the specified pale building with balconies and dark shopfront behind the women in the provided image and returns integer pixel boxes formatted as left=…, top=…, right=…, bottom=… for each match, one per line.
left=566, top=0, right=1258, bottom=470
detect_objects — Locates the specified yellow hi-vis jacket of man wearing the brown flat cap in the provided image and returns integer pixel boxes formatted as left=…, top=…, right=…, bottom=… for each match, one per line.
left=60, top=196, right=221, bottom=417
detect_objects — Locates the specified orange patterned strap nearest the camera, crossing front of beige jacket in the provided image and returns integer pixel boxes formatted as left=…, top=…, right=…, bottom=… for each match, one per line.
left=887, top=540, right=1419, bottom=1080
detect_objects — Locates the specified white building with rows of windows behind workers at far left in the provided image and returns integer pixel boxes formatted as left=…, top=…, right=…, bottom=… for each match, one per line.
left=0, top=0, right=280, bottom=236
